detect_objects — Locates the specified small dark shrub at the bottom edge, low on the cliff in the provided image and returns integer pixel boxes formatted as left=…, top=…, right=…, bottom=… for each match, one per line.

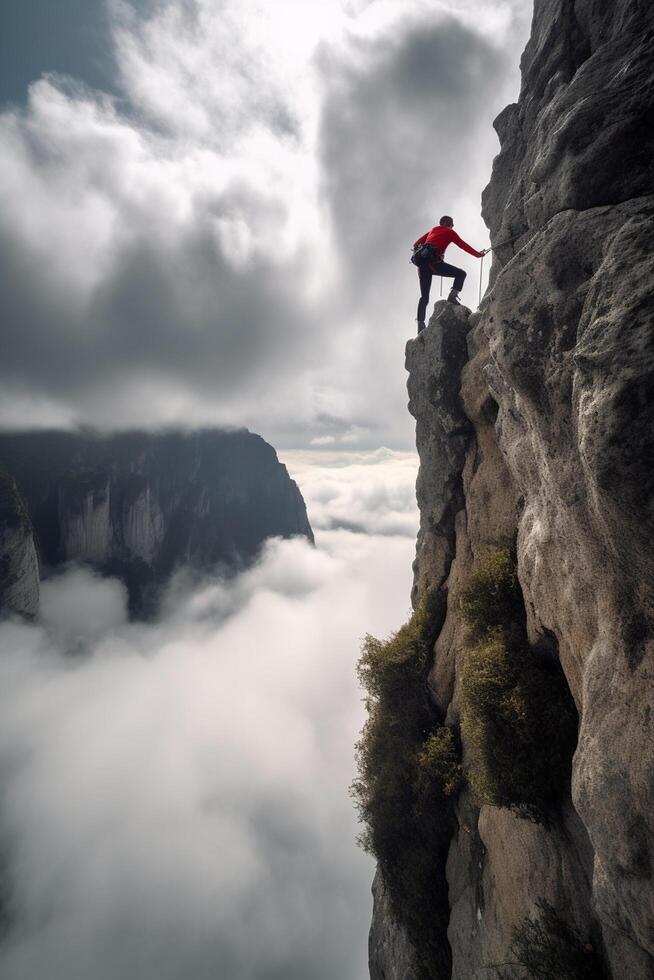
left=499, top=901, right=608, bottom=980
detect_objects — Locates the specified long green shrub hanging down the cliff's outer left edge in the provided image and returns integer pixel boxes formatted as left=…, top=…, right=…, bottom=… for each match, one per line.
left=352, top=595, right=462, bottom=978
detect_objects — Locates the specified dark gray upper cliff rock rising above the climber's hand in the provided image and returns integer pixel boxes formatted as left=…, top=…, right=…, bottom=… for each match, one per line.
left=483, top=0, right=654, bottom=273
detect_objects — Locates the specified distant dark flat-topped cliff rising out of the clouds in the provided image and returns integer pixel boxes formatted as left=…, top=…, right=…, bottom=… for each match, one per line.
left=0, top=430, right=313, bottom=612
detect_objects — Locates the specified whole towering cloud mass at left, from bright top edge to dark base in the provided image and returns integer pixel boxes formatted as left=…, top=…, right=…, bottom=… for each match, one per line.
left=0, top=2, right=328, bottom=436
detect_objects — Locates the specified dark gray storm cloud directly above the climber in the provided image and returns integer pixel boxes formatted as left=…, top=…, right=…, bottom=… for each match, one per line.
left=322, top=11, right=507, bottom=284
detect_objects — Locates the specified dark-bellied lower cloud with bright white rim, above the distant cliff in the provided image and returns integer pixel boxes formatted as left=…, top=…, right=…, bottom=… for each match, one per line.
left=0, top=72, right=328, bottom=425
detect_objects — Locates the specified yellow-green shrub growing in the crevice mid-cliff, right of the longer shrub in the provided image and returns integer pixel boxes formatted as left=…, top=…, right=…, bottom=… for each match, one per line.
left=461, top=550, right=577, bottom=822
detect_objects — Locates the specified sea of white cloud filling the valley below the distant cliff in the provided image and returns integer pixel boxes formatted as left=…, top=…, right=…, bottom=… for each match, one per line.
left=0, top=531, right=413, bottom=980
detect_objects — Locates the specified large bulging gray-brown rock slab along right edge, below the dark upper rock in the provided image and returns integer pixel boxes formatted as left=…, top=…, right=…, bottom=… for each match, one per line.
left=483, top=47, right=654, bottom=977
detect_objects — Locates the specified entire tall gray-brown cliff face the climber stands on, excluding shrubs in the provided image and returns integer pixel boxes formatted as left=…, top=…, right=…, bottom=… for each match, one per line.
left=371, top=0, right=654, bottom=980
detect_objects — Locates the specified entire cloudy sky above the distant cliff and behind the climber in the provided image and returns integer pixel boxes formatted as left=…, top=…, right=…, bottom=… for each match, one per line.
left=0, top=0, right=531, bottom=450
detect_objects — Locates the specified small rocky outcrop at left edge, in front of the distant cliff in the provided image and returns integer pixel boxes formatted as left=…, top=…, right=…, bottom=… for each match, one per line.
left=0, top=473, right=39, bottom=619
